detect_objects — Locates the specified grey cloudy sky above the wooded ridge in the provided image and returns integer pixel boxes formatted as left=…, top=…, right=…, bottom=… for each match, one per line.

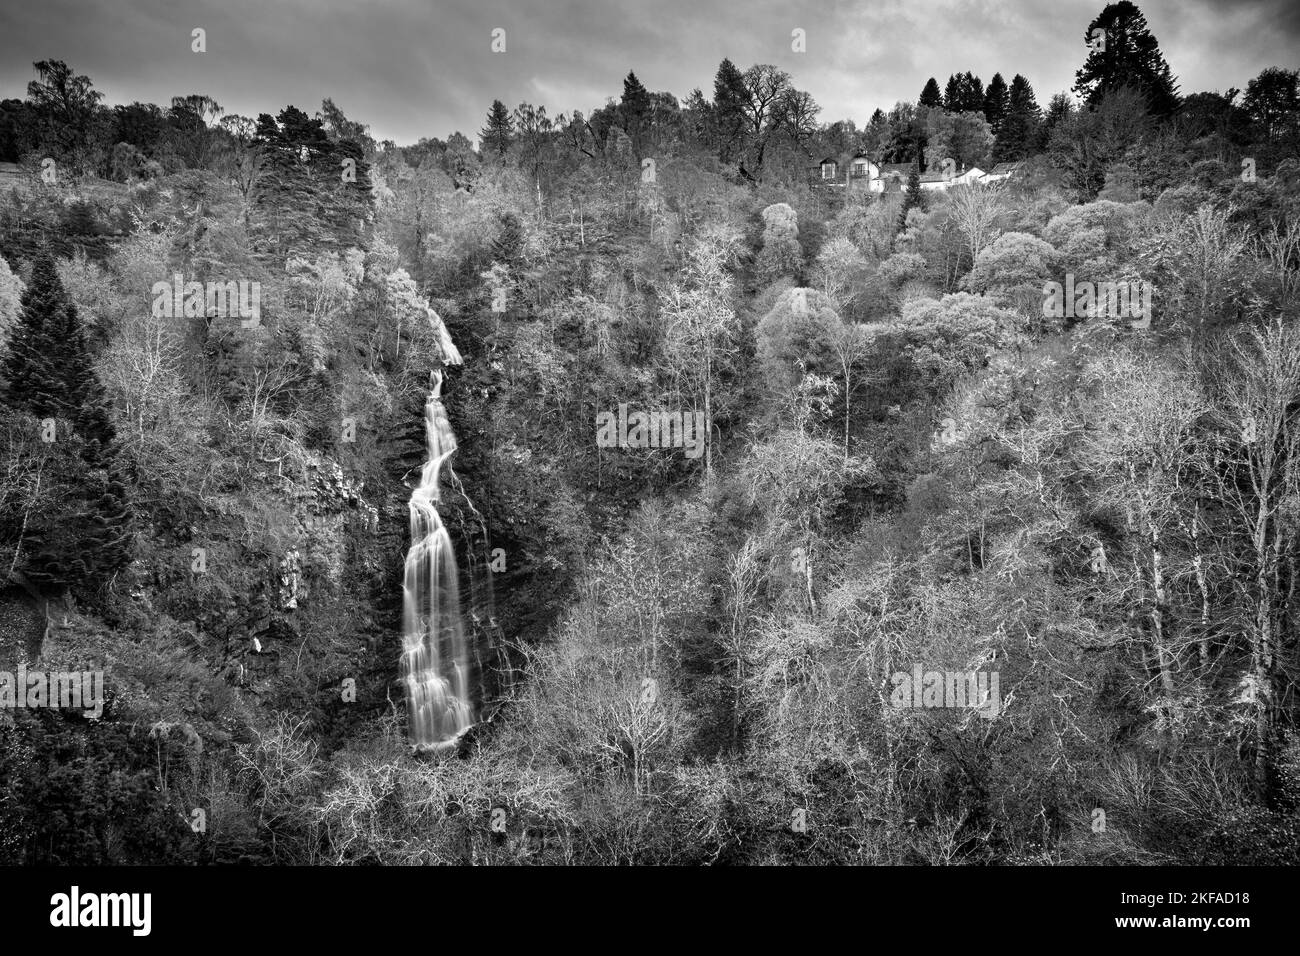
left=0, top=0, right=1300, bottom=143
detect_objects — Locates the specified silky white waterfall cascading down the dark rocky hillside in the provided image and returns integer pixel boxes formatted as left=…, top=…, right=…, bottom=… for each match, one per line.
left=402, top=325, right=473, bottom=750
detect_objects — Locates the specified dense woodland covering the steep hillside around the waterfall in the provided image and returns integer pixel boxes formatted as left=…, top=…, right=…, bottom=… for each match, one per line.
left=0, top=3, right=1300, bottom=865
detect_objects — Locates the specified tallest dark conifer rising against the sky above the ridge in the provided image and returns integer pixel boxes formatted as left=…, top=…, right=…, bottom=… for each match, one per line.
left=1074, top=0, right=1178, bottom=117
